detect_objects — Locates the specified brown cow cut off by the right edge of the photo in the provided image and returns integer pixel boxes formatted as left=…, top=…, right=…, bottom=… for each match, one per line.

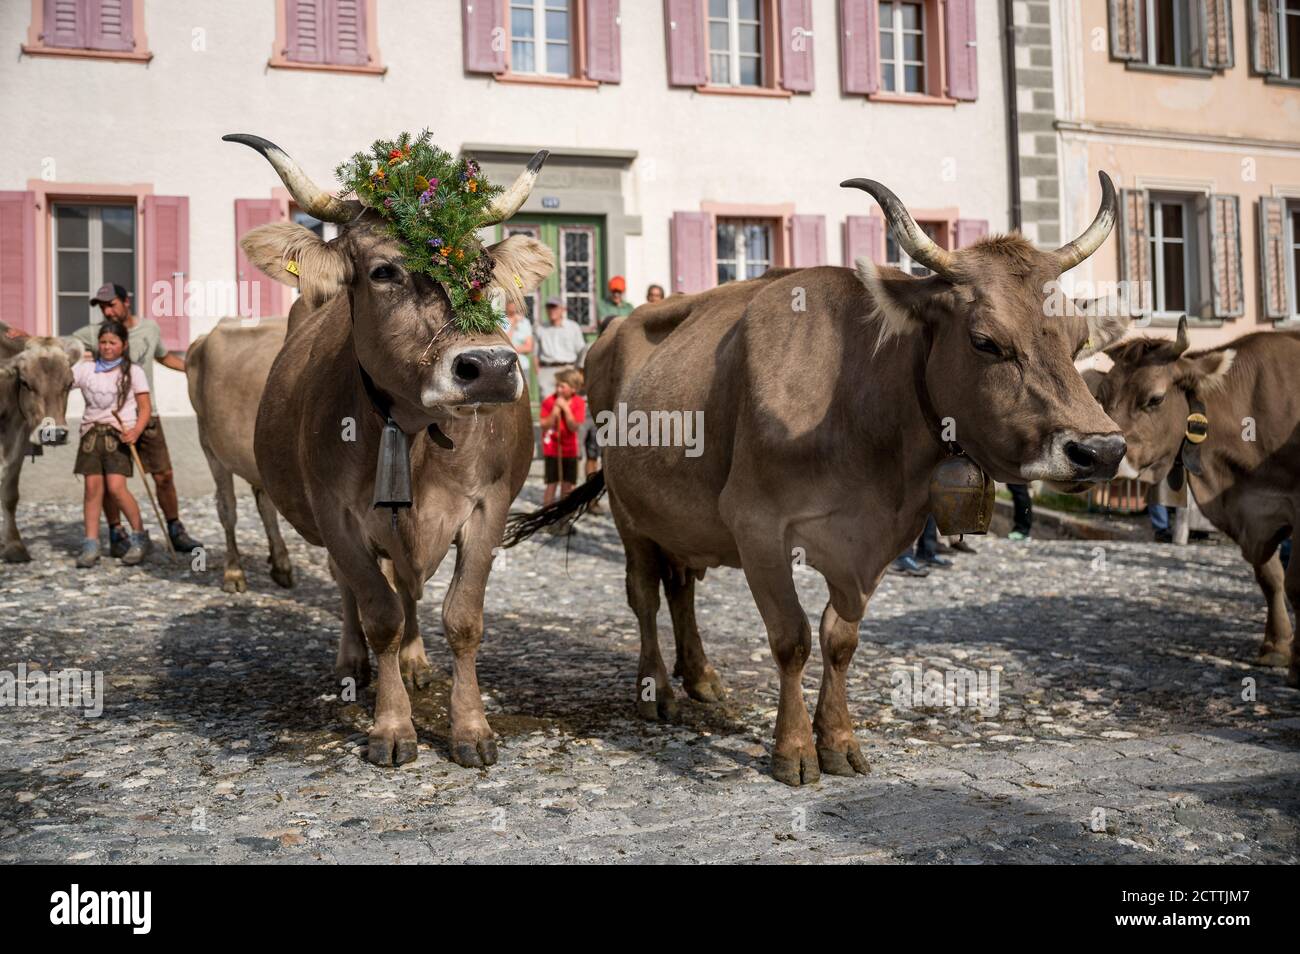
left=1095, top=318, right=1300, bottom=685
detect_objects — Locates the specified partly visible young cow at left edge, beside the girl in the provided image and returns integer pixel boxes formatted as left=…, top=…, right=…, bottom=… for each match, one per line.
left=0, top=330, right=86, bottom=563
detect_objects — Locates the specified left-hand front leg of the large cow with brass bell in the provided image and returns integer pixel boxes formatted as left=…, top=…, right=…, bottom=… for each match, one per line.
left=737, top=528, right=822, bottom=785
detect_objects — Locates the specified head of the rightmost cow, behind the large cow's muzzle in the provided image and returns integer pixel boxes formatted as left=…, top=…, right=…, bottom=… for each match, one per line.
left=1093, top=320, right=1236, bottom=483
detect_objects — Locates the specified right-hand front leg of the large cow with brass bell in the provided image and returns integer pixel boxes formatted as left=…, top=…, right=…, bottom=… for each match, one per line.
left=813, top=585, right=871, bottom=775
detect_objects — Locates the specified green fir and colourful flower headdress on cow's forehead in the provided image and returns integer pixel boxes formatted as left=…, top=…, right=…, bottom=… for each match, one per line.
left=335, top=130, right=502, bottom=333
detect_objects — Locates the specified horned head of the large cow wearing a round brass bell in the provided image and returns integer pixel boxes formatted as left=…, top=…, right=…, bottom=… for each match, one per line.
left=845, top=177, right=1127, bottom=482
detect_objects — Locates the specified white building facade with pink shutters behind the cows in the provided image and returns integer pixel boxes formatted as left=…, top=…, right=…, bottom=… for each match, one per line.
left=0, top=0, right=1009, bottom=415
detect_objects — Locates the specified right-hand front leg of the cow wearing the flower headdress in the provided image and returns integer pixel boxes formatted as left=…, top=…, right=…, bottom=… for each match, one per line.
left=442, top=502, right=508, bottom=768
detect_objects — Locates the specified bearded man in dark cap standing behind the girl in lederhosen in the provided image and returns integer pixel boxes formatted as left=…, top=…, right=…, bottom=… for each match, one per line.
left=73, top=285, right=199, bottom=556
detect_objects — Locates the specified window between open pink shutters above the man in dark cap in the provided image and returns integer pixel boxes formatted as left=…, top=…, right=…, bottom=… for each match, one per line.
left=53, top=204, right=135, bottom=334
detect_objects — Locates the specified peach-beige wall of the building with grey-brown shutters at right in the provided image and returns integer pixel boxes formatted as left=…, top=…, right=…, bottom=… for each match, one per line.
left=1053, top=0, right=1300, bottom=347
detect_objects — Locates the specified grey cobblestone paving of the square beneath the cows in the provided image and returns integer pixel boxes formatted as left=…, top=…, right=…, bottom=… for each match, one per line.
left=0, top=485, right=1300, bottom=863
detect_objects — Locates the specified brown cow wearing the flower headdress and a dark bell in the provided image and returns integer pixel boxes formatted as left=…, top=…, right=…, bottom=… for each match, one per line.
left=226, top=135, right=554, bottom=767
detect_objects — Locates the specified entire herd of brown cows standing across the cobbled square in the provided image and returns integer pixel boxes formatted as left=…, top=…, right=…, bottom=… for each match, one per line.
left=0, top=135, right=1300, bottom=785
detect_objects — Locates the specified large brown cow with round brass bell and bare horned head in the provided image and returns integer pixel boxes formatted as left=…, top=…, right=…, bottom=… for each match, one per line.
left=510, top=174, right=1125, bottom=785
